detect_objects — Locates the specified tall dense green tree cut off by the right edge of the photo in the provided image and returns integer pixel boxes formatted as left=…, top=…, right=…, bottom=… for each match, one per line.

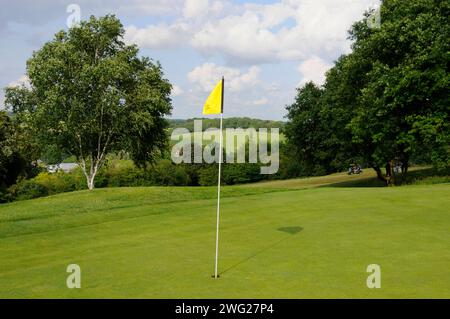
left=349, top=0, right=450, bottom=184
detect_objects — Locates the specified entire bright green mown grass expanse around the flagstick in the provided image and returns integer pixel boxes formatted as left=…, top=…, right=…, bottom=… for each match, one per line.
left=0, top=182, right=450, bottom=298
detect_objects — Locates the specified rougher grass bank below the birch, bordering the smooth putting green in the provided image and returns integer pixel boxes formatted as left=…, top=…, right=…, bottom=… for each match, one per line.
left=0, top=187, right=284, bottom=238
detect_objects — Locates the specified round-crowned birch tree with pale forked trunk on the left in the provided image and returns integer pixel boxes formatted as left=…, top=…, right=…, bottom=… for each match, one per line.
left=5, top=16, right=172, bottom=189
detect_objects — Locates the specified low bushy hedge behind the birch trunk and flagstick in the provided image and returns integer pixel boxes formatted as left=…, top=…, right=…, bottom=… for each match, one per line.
left=3, top=159, right=282, bottom=201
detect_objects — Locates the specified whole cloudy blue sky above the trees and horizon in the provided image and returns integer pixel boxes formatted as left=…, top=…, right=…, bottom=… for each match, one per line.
left=0, top=0, right=378, bottom=120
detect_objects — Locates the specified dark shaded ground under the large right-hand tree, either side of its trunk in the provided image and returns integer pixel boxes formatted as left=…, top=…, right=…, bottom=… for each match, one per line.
left=320, top=168, right=450, bottom=187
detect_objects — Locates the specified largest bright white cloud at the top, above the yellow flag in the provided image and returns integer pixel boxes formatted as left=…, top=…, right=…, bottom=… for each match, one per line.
left=191, top=0, right=372, bottom=63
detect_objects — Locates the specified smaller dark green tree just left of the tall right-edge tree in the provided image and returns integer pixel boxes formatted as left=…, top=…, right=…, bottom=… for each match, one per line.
left=286, top=56, right=361, bottom=175
